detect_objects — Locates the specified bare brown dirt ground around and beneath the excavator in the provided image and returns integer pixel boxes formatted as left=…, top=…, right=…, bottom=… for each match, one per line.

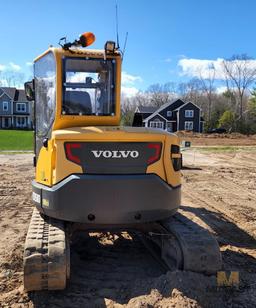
left=0, top=139, right=256, bottom=308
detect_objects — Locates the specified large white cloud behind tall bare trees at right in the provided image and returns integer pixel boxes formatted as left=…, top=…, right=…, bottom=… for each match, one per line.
left=178, top=58, right=256, bottom=80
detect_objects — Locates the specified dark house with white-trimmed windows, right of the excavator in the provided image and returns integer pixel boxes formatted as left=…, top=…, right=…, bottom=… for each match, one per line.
left=133, top=99, right=203, bottom=132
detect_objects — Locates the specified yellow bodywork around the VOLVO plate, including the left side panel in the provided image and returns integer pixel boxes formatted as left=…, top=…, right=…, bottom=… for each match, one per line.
left=36, top=127, right=181, bottom=186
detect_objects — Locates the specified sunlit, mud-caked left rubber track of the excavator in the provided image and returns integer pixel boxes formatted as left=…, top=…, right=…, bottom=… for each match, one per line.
left=23, top=209, right=70, bottom=291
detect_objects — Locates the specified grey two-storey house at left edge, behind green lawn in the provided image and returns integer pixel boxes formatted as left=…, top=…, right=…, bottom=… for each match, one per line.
left=0, top=87, right=33, bottom=129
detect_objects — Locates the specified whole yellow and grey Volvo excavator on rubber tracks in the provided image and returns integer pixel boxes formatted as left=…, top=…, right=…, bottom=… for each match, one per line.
left=24, top=32, right=221, bottom=291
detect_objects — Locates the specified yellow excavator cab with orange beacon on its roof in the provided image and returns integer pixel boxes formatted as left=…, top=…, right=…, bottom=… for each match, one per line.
left=25, top=32, right=121, bottom=158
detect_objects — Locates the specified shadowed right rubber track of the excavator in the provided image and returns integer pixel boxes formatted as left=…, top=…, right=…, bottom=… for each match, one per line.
left=161, top=213, right=222, bottom=274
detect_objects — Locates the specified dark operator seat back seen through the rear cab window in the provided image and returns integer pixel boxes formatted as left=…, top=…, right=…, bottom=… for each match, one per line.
left=63, top=90, right=92, bottom=114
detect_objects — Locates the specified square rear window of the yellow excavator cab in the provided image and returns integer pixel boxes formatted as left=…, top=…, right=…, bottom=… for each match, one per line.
left=62, top=58, right=115, bottom=116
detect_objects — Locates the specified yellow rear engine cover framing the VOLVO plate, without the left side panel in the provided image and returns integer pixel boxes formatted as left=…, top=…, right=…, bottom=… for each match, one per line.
left=49, top=127, right=179, bottom=186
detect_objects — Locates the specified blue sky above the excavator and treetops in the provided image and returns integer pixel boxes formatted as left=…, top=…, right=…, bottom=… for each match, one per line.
left=0, top=0, right=256, bottom=93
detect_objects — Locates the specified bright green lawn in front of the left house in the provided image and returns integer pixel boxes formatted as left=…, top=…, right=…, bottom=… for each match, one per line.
left=0, top=130, right=34, bottom=151
